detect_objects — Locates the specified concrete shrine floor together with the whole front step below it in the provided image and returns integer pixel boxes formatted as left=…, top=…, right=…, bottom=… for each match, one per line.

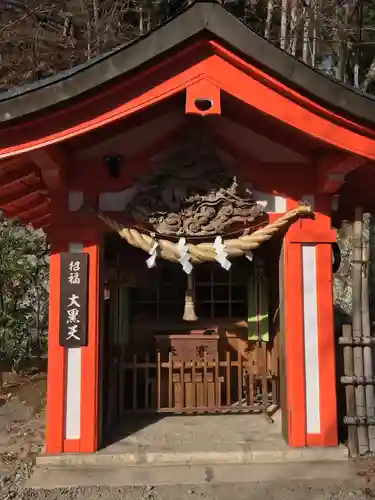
left=28, top=414, right=355, bottom=488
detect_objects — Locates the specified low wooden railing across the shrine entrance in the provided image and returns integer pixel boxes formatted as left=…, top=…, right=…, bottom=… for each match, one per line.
left=120, top=351, right=279, bottom=413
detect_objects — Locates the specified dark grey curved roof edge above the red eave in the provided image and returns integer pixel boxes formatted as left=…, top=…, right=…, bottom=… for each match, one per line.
left=0, top=0, right=375, bottom=127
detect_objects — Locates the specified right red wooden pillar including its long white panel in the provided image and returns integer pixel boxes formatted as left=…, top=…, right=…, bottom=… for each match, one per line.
left=282, top=198, right=337, bottom=446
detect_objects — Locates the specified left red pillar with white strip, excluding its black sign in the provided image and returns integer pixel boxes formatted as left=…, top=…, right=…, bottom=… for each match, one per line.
left=45, top=227, right=101, bottom=454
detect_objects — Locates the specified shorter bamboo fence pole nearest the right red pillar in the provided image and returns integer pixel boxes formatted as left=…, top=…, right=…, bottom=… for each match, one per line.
left=342, top=325, right=358, bottom=458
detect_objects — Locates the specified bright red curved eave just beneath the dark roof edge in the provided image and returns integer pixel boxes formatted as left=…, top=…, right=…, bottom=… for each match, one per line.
left=0, top=41, right=375, bottom=159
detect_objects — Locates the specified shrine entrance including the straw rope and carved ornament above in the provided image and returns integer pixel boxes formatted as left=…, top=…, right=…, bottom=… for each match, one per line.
left=94, top=131, right=311, bottom=446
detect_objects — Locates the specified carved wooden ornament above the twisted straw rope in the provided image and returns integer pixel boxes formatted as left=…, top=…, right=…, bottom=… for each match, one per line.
left=127, top=133, right=265, bottom=238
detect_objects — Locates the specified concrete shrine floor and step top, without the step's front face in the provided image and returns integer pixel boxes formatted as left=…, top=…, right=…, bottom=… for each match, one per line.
left=37, top=412, right=347, bottom=466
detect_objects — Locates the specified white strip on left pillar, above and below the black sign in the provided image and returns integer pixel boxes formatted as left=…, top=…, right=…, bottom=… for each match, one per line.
left=65, top=243, right=83, bottom=439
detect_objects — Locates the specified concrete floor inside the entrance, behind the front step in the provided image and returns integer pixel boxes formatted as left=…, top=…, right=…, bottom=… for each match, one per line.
left=101, top=411, right=288, bottom=454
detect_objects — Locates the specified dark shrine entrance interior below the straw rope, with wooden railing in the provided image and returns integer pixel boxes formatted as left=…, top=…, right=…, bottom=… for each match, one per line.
left=102, top=229, right=282, bottom=439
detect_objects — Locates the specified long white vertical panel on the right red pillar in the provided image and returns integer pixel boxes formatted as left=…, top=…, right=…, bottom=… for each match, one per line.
left=302, top=245, right=320, bottom=434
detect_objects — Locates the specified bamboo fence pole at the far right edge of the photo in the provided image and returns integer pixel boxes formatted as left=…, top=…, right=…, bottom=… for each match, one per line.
left=361, top=214, right=375, bottom=453
